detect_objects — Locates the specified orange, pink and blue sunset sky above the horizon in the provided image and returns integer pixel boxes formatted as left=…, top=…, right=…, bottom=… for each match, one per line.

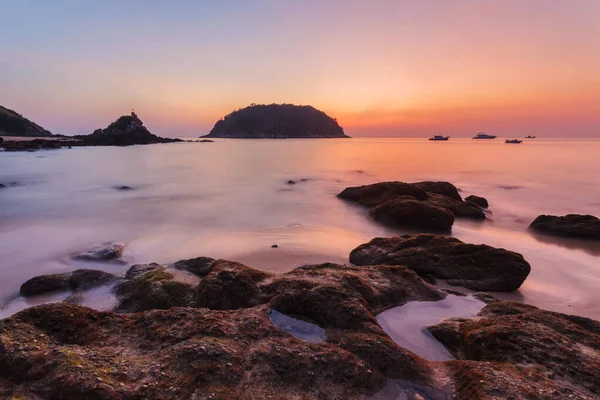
left=0, top=0, right=600, bottom=137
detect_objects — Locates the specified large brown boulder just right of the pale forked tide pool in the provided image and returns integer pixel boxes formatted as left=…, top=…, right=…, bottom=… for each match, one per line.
left=429, top=301, right=600, bottom=398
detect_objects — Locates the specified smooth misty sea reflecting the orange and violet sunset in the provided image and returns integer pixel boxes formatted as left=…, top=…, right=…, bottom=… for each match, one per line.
left=0, top=139, right=600, bottom=319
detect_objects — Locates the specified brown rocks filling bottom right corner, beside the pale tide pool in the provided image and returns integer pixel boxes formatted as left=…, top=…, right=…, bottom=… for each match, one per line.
left=429, top=302, right=600, bottom=399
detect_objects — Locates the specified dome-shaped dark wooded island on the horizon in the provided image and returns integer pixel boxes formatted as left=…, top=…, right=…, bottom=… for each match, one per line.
left=201, top=104, right=348, bottom=139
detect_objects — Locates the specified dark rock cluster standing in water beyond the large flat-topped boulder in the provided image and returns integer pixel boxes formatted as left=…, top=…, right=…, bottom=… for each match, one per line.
left=338, top=182, right=486, bottom=232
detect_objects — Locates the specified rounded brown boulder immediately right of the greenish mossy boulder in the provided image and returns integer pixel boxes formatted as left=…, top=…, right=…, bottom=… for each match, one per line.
left=194, top=260, right=270, bottom=310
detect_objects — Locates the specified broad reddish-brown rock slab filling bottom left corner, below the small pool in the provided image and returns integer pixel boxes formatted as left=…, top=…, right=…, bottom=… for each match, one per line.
left=0, top=303, right=390, bottom=399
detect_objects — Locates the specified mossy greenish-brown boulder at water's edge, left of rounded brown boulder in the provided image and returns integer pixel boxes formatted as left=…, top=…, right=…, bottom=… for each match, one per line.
left=115, top=264, right=194, bottom=312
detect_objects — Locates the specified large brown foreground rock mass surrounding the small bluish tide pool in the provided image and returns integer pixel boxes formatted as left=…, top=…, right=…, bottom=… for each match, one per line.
left=0, top=260, right=444, bottom=399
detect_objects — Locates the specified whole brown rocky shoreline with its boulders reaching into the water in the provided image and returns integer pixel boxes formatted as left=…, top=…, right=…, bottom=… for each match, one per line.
left=0, top=182, right=600, bottom=400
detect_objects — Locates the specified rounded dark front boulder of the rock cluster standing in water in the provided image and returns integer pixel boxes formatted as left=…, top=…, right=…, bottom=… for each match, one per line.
left=369, top=197, right=454, bottom=232
